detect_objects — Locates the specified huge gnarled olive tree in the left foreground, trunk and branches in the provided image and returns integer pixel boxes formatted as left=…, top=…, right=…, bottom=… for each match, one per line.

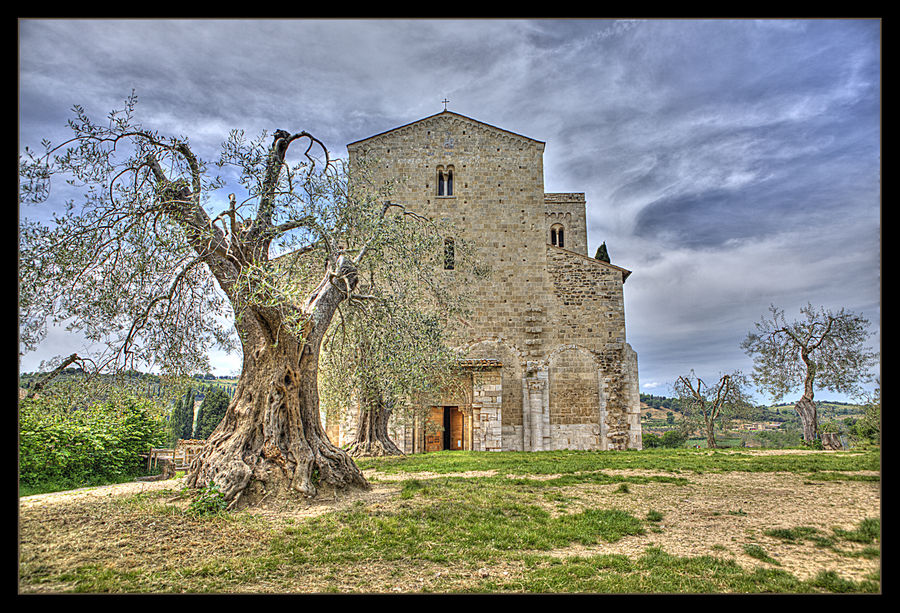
left=19, top=95, right=464, bottom=506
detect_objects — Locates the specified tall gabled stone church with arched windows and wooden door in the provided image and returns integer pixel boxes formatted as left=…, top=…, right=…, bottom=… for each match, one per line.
left=327, top=110, right=641, bottom=453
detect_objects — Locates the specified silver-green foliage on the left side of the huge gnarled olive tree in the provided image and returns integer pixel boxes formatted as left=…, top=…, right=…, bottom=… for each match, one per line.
left=19, top=96, right=233, bottom=372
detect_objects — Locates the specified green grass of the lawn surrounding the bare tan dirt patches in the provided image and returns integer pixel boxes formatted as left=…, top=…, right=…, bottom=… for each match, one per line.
left=20, top=450, right=880, bottom=593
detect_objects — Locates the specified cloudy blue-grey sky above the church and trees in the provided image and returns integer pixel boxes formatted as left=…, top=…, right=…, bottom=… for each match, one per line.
left=19, top=19, right=881, bottom=400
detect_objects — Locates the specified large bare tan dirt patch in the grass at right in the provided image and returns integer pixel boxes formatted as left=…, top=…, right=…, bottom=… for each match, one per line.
left=554, top=471, right=881, bottom=581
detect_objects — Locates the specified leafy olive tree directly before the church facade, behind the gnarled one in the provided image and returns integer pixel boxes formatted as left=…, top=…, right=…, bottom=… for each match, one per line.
left=319, top=214, right=490, bottom=456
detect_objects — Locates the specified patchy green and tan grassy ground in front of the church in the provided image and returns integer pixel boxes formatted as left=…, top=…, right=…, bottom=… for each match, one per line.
left=19, top=449, right=881, bottom=593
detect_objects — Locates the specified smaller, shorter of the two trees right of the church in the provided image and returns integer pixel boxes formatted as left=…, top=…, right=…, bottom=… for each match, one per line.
left=675, top=371, right=750, bottom=449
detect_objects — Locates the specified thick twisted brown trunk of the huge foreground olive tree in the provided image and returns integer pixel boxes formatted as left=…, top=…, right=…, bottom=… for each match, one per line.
left=188, top=258, right=369, bottom=507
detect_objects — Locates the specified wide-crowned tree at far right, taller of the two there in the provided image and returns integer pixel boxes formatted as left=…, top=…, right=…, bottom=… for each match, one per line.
left=741, top=304, right=877, bottom=444
